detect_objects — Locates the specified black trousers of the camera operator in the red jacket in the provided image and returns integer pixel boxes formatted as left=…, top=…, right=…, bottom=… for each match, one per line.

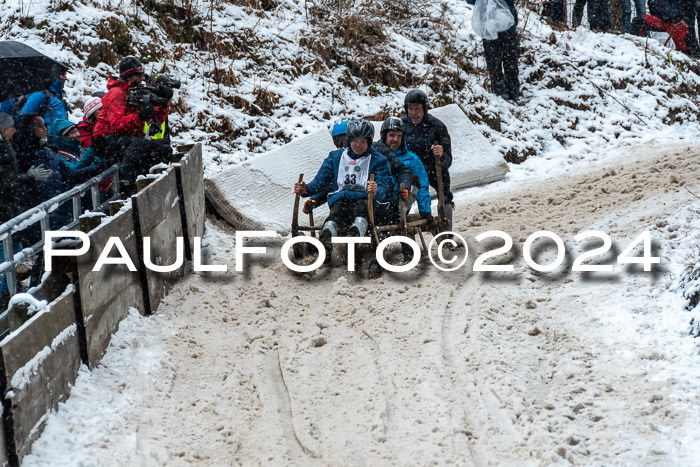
left=93, top=134, right=173, bottom=183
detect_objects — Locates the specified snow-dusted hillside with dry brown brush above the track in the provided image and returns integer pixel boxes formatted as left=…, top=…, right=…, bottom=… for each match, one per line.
left=0, top=0, right=700, bottom=174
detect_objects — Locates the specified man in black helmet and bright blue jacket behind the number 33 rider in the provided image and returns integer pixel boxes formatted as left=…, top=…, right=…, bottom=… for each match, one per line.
left=379, top=117, right=432, bottom=219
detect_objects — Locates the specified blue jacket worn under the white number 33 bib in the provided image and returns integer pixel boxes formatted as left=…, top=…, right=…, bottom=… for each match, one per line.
left=306, top=148, right=392, bottom=206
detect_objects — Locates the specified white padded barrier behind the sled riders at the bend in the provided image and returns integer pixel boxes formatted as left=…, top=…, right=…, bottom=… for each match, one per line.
left=205, top=104, right=508, bottom=232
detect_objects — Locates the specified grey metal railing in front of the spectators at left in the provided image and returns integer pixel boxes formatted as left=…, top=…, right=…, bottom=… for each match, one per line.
left=0, top=165, right=119, bottom=296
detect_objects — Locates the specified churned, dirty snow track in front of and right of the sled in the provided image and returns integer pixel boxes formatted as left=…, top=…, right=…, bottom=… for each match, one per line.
left=26, top=146, right=700, bottom=465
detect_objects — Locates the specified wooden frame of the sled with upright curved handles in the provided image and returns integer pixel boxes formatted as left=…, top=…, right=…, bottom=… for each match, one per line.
left=291, top=157, right=448, bottom=259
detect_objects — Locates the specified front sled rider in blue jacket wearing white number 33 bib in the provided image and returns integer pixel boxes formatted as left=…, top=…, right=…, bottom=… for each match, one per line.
left=294, top=120, right=391, bottom=262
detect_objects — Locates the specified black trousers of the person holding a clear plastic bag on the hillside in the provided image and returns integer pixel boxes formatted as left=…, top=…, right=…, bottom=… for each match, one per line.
left=482, top=30, right=520, bottom=100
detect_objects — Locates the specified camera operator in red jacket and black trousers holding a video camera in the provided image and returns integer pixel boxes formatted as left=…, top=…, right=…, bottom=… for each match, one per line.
left=92, top=56, right=173, bottom=192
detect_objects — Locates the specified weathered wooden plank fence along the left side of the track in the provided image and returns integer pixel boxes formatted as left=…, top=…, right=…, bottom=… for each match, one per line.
left=0, top=145, right=204, bottom=466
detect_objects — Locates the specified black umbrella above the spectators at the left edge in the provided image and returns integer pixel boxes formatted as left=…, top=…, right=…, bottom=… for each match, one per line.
left=0, top=41, right=68, bottom=102
